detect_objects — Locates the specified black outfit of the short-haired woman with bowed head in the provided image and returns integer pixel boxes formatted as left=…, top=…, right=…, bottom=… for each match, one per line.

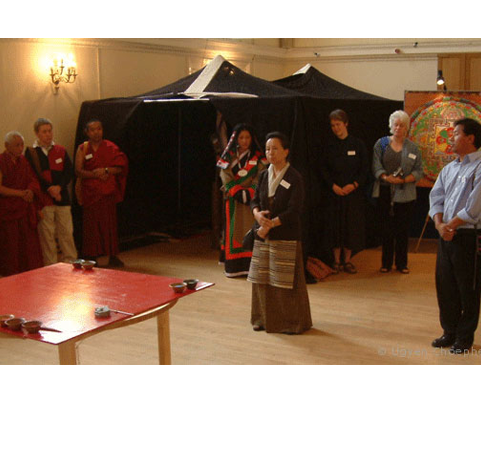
left=320, top=135, right=369, bottom=255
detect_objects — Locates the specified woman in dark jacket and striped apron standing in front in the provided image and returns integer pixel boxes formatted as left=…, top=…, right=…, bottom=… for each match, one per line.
left=247, top=132, right=312, bottom=334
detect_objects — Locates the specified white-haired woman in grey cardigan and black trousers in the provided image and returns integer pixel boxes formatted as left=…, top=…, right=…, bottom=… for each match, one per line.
left=372, top=111, right=423, bottom=274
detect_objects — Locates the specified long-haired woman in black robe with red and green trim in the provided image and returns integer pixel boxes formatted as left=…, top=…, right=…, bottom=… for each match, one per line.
left=217, top=123, right=267, bottom=278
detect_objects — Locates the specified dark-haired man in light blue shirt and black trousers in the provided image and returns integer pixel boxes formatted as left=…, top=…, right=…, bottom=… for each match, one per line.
left=429, top=119, right=481, bottom=353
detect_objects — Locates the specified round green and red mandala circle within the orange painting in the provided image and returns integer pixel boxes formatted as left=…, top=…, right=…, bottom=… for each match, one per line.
left=409, top=96, right=481, bottom=185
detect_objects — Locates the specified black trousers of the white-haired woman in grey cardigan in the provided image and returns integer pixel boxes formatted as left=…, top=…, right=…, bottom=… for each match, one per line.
left=378, top=186, right=415, bottom=269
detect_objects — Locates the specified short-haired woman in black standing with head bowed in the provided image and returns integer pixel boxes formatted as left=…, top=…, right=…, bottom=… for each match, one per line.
left=320, top=109, right=369, bottom=273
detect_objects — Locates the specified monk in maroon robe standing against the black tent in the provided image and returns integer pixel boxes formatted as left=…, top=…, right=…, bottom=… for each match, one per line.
left=75, top=120, right=128, bottom=267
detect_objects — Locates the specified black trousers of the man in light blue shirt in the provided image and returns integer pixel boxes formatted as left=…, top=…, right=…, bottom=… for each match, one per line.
left=436, top=230, right=481, bottom=344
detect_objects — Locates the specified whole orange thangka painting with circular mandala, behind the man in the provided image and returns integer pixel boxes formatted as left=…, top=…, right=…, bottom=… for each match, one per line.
left=404, top=91, right=481, bottom=187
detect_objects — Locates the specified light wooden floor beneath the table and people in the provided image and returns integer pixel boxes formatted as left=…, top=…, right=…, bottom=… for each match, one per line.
left=0, top=236, right=481, bottom=365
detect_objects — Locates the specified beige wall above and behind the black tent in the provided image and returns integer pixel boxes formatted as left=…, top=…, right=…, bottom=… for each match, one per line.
left=0, top=38, right=481, bottom=160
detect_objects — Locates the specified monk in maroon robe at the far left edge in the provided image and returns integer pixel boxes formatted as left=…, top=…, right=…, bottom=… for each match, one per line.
left=0, top=131, right=43, bottom=276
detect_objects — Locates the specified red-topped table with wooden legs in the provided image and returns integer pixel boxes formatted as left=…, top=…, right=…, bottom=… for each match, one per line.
left=0, top=263, right=213, bottom=364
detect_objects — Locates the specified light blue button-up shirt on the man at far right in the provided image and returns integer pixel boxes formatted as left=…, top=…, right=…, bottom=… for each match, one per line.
left=429, top=151, right=481, bottom=228
